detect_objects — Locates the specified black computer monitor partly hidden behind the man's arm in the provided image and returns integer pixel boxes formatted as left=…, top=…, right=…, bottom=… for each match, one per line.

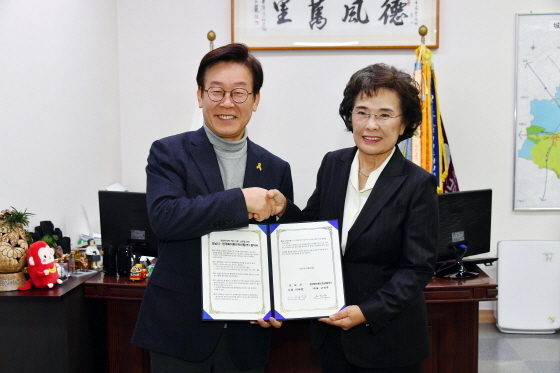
left=99, top=190, right=158, bottom=275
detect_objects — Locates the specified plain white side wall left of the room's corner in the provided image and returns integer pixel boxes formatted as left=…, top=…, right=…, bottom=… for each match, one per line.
left=0, top=0, right=121, bottom=238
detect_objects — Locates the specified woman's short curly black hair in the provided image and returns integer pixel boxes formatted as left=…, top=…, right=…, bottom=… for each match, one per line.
left=338, top=63, right=422, bottom=143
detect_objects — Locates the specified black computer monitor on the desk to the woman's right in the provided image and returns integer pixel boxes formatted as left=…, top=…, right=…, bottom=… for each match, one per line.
left=436, top=189, right=492, bottom=278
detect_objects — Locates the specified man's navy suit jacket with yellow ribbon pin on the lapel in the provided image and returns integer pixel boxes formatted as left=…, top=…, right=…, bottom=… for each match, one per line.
left=132, top=128, right=293, bottom=369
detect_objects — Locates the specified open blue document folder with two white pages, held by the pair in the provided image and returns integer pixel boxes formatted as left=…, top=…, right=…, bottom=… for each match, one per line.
left=202, top=221, right=345, bottom=320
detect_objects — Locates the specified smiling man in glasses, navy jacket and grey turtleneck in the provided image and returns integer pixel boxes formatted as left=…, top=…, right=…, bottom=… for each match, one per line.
left=132, top=44, right=293, bottom=373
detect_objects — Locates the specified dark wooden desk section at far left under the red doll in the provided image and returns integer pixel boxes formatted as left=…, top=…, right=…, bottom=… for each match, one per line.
left=0, top=272, right=98, bottom=373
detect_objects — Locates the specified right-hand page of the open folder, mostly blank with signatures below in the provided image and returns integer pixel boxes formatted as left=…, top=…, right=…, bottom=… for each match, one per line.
left=270, top=221, right=345, bottom=320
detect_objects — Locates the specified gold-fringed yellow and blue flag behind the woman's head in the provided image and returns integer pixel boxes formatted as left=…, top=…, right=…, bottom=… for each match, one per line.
left=403, top=39, right=459, bottom=193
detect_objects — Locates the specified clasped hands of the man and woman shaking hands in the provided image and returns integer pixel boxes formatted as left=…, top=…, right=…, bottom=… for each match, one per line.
left=241, top=187, right=288, bottom=221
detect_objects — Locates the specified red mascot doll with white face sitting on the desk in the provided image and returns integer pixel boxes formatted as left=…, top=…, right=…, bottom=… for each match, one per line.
left=18, top=241, right=62, bottom=290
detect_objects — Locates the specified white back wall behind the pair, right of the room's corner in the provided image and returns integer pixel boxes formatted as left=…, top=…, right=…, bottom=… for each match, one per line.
left=119, top=0, right=560, bottom=274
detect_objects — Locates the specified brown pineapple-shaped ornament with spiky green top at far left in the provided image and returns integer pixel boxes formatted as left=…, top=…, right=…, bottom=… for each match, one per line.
left=0, top=207, right=33, bottom=291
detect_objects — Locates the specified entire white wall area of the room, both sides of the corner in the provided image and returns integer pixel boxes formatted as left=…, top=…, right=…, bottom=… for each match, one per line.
left=0, top=0, right=560, bottom=308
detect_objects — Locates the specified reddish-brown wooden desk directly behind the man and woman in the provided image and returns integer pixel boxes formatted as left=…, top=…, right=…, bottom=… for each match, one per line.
left=84, top=271, right=498, bottom=373
